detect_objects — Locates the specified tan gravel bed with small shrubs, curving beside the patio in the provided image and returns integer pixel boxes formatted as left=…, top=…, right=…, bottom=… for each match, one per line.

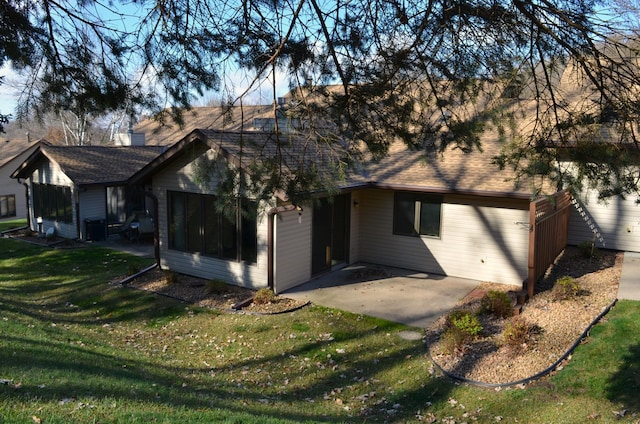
left=426, top=248, right=623, bottom=384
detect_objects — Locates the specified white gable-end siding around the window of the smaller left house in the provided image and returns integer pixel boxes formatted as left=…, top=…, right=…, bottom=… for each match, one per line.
left=29, top=161, right=79, bottom=239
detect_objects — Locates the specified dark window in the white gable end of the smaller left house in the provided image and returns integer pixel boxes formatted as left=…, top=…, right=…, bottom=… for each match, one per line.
left=33, top=183, right=73, bottom=224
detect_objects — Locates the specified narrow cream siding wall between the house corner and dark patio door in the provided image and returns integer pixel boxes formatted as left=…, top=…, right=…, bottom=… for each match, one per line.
left=274, top=207, right=313, bottom=293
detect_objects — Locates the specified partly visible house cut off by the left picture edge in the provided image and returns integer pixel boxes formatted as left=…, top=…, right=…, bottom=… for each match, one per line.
left=0, top=139, right=41, bottom=220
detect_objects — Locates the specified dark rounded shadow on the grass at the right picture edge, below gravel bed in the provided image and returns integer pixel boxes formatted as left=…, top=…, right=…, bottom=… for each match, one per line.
left=606, top=344, right=640, bottom=413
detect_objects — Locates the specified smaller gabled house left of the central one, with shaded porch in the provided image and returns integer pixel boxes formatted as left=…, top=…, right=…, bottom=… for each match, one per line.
left=11, top=145, right=164, bottom=240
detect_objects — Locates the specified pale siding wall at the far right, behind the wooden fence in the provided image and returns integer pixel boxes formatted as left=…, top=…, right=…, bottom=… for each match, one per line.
left=569, top=190, right=640, bottom=252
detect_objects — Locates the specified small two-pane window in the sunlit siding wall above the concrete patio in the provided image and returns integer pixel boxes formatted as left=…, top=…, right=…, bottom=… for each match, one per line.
left=393, top=192, right=442, bottom=237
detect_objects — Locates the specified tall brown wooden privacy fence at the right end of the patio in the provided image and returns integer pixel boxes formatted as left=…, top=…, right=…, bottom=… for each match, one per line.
left=527, top=190, right=571, bottom=298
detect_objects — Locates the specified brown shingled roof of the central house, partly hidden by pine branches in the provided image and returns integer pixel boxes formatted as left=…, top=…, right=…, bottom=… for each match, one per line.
left=132, top=124, right=535, bottom=199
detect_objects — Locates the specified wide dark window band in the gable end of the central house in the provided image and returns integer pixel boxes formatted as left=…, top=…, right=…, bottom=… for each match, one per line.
left=168, top=191, right=258, bottom=263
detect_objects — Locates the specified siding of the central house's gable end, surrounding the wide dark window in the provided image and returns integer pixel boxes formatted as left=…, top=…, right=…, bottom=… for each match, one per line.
left=153, top=147, right=268, bottom=289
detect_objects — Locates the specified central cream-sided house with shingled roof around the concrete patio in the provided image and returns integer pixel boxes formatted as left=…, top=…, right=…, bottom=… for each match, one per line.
left=131, top=126, right=544, bottom=292
